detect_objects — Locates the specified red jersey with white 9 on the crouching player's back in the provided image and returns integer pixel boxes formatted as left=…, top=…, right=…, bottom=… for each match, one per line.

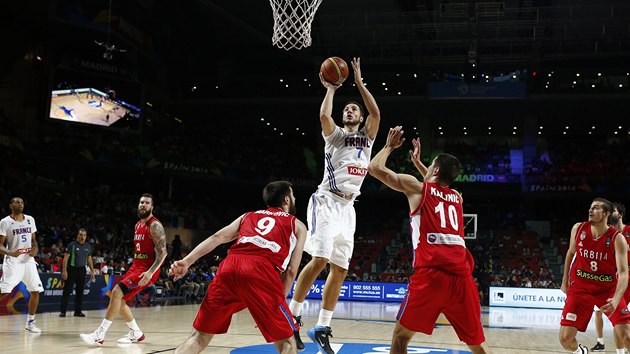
left=230, top=208, right=297, bottom=272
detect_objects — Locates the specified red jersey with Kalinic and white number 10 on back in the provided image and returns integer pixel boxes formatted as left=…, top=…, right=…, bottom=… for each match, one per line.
left=410, top=182, right=474, bottom=275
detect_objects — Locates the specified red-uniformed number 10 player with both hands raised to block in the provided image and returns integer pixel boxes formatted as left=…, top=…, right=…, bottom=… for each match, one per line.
left=369, top=126, right=490, bottom=354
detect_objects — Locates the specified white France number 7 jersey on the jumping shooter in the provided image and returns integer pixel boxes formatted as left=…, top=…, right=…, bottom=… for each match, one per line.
left=318, top=126, right=374, bottom=198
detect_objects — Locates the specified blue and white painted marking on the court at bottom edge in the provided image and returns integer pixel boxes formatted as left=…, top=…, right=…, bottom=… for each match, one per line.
left=231, top=343, right=471, bottom=354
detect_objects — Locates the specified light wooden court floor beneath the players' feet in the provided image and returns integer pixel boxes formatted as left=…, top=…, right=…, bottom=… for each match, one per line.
left=0, top=300, right=614, bottom=354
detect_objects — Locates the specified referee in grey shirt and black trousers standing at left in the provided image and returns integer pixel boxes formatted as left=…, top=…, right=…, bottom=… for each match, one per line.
left=59, top=228, right=94, bottom=317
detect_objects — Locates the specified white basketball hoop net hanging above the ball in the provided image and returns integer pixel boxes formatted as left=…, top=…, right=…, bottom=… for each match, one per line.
left=269, top=0, right=322, bottom=50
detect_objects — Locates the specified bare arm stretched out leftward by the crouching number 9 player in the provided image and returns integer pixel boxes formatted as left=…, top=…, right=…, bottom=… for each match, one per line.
left=168, top=214, right=244, bottom=281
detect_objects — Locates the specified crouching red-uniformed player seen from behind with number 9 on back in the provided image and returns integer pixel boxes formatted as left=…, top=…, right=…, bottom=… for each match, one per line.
left=169, top=181, right=306, bottom=354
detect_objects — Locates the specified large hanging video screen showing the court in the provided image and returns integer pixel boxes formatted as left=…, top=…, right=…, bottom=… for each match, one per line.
left=49, top=68, right=142, bottom=130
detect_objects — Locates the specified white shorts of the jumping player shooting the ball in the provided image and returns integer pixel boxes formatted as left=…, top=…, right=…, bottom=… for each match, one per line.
left=304, top=191, right=356, bottom=269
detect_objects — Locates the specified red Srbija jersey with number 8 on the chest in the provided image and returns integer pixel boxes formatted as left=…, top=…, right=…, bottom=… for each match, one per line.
left=569, top=221, right=618, bottom=295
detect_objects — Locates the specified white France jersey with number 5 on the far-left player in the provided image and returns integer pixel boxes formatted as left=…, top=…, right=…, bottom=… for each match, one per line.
left=0, top=214, right=37, bottom=263
